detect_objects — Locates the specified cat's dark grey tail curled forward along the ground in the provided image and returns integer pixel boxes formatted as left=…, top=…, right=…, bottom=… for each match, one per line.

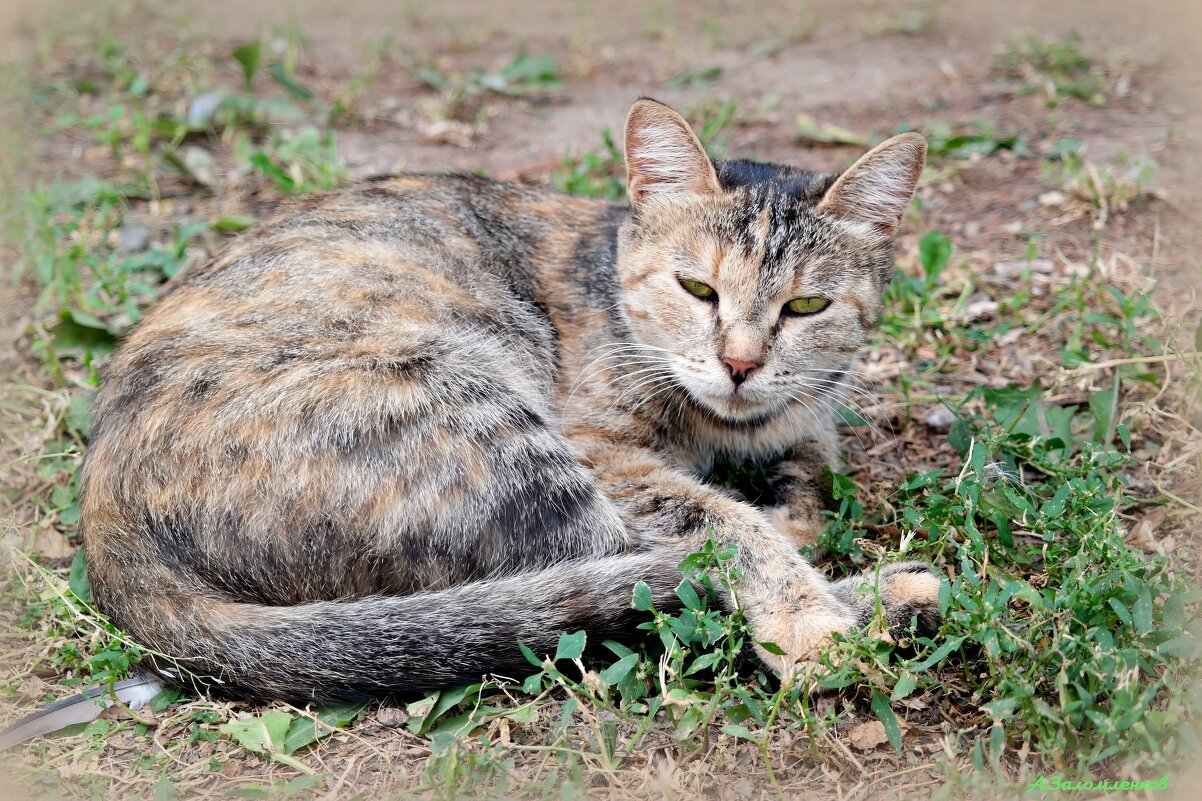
left=106, top=546, right=690, bottom=701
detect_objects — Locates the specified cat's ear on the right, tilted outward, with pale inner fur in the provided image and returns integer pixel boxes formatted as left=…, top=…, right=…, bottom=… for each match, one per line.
left=817, top=134, right=927, bottom=236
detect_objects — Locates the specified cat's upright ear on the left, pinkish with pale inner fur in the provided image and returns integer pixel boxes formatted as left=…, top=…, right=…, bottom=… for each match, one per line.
left=624, top=97, right=719, bottom=206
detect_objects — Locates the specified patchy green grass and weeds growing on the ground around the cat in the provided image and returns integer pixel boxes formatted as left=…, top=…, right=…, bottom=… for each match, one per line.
left=0, top=6, right=1202, bottom=799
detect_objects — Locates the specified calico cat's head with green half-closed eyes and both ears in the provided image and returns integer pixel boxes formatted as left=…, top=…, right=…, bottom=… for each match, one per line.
left=618, top=99, right=927, bottom=421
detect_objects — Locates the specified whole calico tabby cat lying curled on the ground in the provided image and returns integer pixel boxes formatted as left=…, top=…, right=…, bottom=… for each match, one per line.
left=82, top=99, right=939, bottom=700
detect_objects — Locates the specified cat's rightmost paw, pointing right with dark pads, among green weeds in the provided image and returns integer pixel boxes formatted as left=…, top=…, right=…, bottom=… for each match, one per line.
left=833, top=562, right=940, bottom=641
